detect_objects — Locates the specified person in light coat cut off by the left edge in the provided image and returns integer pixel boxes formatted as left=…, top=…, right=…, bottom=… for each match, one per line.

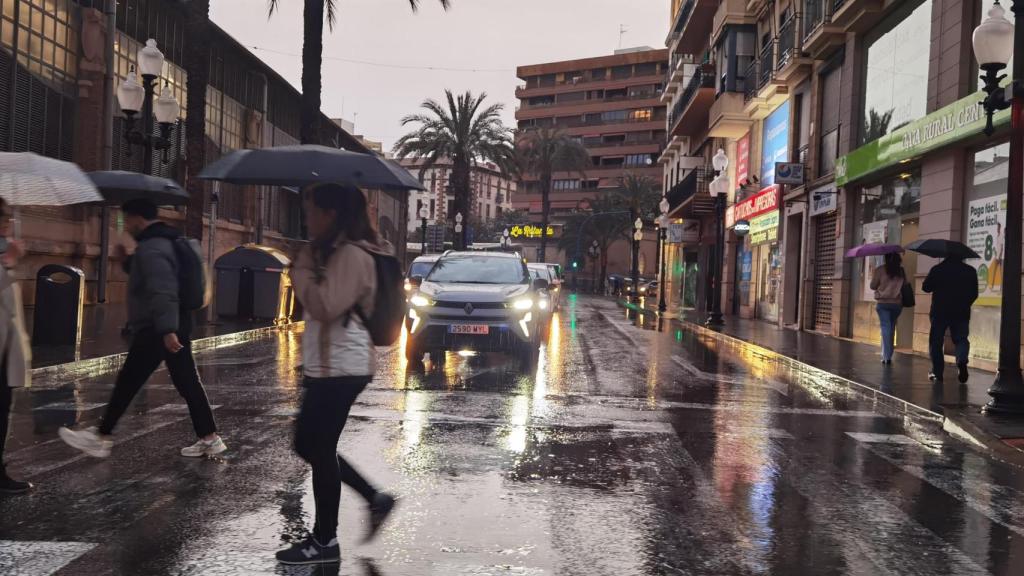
left=0, top=199, right=32, bottom=494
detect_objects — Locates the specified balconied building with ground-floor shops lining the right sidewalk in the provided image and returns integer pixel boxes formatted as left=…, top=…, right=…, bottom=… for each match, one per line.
left=662, top=0, right=1013, bottom=364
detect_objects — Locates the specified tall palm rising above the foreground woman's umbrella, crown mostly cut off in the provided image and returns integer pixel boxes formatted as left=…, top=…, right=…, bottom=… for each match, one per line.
left=267, top=0, right=451, bottom=143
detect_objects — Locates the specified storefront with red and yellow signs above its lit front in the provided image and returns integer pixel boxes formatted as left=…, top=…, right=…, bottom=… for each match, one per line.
left=725, top=186, right=782, bottom=322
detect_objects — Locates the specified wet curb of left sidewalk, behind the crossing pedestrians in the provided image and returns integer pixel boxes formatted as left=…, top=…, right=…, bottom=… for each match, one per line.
left=30, top=322, right=303, bottom=389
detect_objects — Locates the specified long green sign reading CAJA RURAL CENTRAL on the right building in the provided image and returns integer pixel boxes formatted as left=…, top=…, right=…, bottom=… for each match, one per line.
left=836, top=92, right=1010, bottom=186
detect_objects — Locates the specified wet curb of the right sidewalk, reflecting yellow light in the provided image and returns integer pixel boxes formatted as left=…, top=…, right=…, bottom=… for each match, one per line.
left=680, top=320, right=942, bottom=432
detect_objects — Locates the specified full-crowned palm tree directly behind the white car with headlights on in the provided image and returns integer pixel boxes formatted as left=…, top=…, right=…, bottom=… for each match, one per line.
left=394, top=90, right=515, bottom=249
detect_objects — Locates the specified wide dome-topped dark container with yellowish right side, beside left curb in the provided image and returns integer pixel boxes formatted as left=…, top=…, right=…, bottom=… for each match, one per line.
left=214, top=244, right=295, bottom=324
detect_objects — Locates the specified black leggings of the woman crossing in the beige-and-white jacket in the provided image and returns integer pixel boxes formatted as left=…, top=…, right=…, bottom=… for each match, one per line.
left=295, top=376, right=377, bottom=544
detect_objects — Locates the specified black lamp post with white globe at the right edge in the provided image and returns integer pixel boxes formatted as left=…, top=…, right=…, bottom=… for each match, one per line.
left=974, top=0, right=1024, bottom=416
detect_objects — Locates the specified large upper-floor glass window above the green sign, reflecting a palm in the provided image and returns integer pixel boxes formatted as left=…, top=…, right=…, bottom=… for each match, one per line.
left=860, top=0, right=932, bottom=143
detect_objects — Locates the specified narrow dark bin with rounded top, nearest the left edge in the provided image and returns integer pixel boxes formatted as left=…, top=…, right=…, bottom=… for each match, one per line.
left=32, top=264, right=85, bottom=346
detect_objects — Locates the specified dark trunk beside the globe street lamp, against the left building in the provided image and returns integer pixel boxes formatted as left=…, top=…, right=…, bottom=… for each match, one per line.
left=184, top=0, right=210, bottom=240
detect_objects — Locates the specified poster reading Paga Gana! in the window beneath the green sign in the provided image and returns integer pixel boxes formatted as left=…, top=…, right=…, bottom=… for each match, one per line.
left=967, top=194, right=1007, bottom=306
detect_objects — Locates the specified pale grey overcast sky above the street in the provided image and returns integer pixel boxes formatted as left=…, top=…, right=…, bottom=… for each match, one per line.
left=211, top=0, right=670, bottom=149
